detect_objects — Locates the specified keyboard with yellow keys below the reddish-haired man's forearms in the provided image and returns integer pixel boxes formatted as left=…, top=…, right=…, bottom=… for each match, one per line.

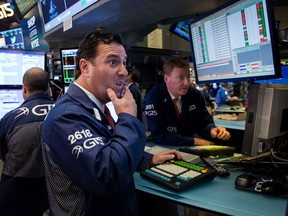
left=179, top=145, right=236, bottom=157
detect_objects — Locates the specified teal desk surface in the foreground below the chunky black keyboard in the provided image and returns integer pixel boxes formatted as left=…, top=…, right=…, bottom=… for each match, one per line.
left=134, top=171, right=287, bottom=216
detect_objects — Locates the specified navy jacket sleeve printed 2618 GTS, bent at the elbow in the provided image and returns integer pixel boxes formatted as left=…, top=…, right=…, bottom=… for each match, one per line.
left=43, top=105, right=146, bottom=196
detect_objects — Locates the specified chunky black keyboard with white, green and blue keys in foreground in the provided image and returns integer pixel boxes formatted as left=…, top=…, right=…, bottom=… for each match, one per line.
left=140, top=160, right=217, bottom=191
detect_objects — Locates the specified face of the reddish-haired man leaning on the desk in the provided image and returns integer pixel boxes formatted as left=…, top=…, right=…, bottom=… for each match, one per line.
left=164, top=67, right=189, bottom=97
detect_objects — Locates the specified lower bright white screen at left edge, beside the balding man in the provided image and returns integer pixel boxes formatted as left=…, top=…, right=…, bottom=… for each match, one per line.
left=0, top=88, right=24, bottom=119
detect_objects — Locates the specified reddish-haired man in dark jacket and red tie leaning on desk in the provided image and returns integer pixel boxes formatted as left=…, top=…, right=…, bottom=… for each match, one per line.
left=145, top=57, right=230, bottom=146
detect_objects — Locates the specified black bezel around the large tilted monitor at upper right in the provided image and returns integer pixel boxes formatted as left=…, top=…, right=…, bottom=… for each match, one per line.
left=189, top=0, right=282, bottom=84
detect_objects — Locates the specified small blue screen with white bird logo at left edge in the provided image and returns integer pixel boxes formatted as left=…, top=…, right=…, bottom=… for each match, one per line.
left=0, top=28, right=25, bottom=49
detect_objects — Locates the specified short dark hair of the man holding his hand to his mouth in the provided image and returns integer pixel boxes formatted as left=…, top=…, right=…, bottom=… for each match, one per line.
left=75, top=32, right=123, bottom=79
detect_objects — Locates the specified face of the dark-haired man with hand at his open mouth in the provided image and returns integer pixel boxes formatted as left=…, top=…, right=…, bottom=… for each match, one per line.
left=81, top=43, right=128, bottom=103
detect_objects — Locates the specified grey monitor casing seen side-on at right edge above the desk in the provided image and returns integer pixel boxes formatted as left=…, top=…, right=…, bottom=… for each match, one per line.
left=242, top=83, right=288, bottom=156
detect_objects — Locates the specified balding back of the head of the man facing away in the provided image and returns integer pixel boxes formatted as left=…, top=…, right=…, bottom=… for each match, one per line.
left=22, top=67, right=49, bottom=93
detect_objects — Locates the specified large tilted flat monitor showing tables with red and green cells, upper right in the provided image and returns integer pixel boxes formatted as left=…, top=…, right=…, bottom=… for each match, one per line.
left=189, top=0, right=281, bottom=83
